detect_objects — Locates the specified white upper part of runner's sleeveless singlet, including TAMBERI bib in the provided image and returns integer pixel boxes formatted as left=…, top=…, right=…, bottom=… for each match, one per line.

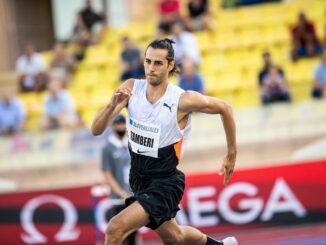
left=127, top=79, right=191, bottom=158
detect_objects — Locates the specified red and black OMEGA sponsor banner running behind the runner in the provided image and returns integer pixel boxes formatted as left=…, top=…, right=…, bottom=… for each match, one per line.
left=0, top=161, right=326, bottom=245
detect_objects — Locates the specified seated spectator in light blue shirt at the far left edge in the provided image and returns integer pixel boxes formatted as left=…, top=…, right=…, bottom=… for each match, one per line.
left=0, top=91, right=26, bottom=136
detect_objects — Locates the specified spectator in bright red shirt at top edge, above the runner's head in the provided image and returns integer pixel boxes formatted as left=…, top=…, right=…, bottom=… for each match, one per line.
left=159, top=0, right=181, bottom=33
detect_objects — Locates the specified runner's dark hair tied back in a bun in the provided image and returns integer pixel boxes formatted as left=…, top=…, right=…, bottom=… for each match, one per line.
left=145, top=38, right=180, bottom=76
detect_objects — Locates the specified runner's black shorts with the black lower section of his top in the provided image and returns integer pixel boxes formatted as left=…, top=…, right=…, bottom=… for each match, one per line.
left=126, top=144, right=185, bottom=230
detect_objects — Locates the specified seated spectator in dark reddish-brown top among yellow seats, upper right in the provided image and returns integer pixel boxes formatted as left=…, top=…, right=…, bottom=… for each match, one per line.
left=292, top=12, right=322, bottom=61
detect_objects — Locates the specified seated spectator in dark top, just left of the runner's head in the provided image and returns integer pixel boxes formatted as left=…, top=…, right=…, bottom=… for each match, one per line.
left=120, top=37, right=145, bottom=81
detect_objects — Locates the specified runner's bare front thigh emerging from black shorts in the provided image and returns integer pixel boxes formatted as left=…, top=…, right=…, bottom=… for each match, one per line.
left=112, top=201, right=149, bottom=234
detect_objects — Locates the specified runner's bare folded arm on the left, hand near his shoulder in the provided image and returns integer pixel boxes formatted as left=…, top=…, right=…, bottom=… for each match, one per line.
left=91, top=79, right=134, bottom=135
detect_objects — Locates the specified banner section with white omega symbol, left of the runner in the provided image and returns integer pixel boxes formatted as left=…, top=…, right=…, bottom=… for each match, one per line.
left=0, top=186, right=95, bottom=245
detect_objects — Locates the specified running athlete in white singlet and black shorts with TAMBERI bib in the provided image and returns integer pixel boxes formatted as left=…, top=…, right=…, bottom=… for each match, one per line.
left=92, top=39, right=238, bottom=245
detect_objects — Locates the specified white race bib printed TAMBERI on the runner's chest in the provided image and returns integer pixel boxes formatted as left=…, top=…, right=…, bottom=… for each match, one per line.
left=128, top=118, right=161, bottom=158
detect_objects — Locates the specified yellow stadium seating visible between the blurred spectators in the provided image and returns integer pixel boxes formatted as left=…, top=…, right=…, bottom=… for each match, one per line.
left=6, top=0, right=326, bottom=130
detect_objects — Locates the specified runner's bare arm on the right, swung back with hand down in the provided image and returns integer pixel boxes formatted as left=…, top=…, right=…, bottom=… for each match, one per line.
left=178, top=91, right=237, bottom=184
